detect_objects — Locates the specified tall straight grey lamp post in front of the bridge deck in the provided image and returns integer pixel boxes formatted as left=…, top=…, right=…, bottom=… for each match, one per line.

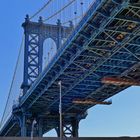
left=58, top=81, right=63, bottom=140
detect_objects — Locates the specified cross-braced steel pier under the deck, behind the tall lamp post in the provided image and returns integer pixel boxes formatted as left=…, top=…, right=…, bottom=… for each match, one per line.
left=55, top=118, right=79, bottom=137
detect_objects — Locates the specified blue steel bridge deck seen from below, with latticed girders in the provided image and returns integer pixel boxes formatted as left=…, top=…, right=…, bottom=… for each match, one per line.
left=0, top=0, right=140, bottom=136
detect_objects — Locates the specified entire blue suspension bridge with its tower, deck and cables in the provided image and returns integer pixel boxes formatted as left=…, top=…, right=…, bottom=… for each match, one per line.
left=0, top=0, right=140, bottom=137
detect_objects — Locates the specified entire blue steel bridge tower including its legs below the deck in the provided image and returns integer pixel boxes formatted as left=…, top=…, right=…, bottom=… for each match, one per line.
left=13, top=15, right=75, bottom=136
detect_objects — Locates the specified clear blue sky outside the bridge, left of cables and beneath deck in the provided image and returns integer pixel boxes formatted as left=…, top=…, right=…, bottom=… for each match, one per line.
left=0, top=0, right=140, bottom=136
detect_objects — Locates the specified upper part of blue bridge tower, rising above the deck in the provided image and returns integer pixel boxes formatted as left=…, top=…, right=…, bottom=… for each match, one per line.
left=21, top=15, right=73, bottom=94
